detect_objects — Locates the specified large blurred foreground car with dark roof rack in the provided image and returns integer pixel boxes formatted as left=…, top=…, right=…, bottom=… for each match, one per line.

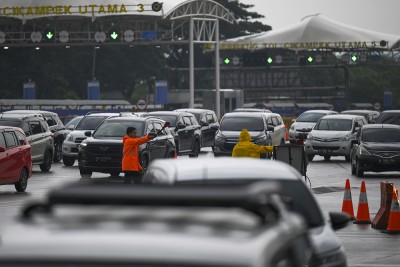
left=0, top=184, right=311, bottom=267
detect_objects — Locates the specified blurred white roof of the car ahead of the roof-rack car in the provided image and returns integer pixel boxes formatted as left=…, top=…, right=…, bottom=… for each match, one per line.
left=149, top=157, right=302, bottom=183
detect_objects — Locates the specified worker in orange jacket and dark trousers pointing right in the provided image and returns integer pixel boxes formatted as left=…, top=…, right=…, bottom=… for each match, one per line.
left=122, top=127, right=156, bottom=184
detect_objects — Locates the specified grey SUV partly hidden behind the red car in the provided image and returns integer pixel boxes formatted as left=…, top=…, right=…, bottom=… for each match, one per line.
left=0, top=113, right=54, bottom=172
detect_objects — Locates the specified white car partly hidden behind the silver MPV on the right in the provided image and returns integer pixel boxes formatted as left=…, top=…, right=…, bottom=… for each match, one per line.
left=289, top=110, right=338, bottom=145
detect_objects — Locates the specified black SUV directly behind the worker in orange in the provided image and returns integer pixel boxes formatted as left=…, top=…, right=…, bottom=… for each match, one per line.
left=78, top=116, right=176, bottom=178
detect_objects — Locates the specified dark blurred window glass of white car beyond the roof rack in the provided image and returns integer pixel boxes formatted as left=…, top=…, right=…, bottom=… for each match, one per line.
left=177, top=179, right=324, bottom=227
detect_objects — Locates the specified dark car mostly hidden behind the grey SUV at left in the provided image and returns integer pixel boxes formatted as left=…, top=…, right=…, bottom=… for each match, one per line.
left=3, top=110, right=71, bottom=162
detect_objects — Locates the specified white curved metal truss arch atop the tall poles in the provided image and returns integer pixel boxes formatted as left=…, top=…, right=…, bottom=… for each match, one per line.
left=165, top=0, right=236, bottom=23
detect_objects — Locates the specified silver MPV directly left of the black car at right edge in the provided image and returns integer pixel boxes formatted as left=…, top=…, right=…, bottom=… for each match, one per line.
left=304, top=114, right=368, bottom=161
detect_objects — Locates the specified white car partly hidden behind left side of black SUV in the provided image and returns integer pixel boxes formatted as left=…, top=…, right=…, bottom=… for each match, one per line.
left=62, top=113, right=119, bottom=166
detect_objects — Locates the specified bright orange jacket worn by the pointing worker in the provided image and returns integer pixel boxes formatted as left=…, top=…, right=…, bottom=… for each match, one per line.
left=122, top=135, right=150, bottom=171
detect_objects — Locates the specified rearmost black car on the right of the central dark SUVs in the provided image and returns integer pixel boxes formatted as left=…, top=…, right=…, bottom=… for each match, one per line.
left=175, top=108, right=219, bottom=149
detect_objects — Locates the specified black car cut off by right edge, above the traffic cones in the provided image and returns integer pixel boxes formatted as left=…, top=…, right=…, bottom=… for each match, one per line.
left=350, top=124, right=400, bottom=177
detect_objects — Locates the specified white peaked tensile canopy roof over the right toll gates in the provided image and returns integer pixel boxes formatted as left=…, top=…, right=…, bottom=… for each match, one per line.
left=220, top=14, right=400, bottom=50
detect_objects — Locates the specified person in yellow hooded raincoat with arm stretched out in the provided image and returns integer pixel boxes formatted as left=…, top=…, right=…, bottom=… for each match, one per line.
left=232, top=129, right=274, bottom=158
